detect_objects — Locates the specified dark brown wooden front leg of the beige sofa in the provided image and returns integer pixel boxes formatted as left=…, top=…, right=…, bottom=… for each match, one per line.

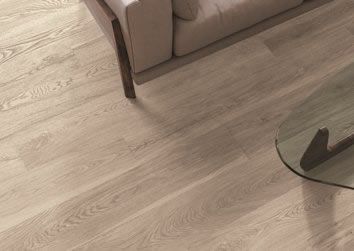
left=112, top=19, right=136, bottom=98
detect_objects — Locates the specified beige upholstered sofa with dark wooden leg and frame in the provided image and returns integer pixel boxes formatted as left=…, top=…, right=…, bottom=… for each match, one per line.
left=86, top=0, right=318, bottom=98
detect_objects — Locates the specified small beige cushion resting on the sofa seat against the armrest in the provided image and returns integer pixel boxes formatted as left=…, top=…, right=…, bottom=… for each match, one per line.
left=172, top=0, right=198, bottom=20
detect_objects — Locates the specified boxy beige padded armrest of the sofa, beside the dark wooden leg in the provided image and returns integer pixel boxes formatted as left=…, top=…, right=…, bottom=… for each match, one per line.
left=105, top=0, right=173, bottom=73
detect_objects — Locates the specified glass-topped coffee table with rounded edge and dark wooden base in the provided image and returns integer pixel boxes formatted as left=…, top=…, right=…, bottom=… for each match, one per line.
left=276, top=63, right=354, bottom=189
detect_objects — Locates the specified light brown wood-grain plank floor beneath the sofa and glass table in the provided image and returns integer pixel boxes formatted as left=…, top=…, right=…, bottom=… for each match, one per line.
left=0, top=0, right=354, bottom=250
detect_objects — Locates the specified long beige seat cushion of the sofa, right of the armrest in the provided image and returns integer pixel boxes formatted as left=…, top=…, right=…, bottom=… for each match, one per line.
left=174, top=0, right=303, bottom=56
